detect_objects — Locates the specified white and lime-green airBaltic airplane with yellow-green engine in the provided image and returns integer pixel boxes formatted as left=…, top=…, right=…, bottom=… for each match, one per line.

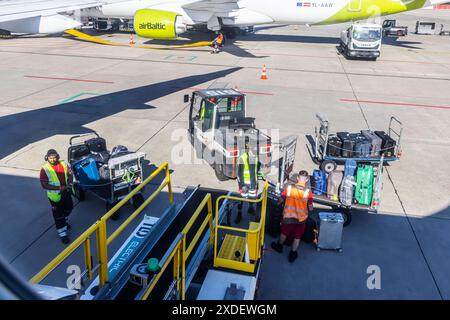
left=0, top=0, right=448, bottom=39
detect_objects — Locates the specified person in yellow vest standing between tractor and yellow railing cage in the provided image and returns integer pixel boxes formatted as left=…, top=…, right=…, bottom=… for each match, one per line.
left=235, top=138, right=262, bottom=224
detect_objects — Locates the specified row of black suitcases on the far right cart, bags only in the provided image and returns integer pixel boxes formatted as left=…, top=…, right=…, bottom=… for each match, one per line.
left=327, top=130, right=396, bottom=158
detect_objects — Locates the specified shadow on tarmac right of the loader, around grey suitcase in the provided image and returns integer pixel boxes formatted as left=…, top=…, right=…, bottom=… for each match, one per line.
left=259, top=202, right=450, bottom=300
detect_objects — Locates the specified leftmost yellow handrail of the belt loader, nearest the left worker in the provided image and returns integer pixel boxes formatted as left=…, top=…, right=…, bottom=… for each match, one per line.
left=30, top=162, right=173, bottom=288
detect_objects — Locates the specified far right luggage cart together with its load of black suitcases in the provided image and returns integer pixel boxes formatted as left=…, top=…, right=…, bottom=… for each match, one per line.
left=310, top=114, right=403, bottom=173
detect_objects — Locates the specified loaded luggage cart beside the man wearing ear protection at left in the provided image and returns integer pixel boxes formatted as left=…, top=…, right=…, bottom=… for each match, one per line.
left=68, top=132, right=145, bottom=218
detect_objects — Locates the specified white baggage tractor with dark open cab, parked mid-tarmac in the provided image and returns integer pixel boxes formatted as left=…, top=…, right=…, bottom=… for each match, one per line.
left=184, top=89, right=272, bottom=181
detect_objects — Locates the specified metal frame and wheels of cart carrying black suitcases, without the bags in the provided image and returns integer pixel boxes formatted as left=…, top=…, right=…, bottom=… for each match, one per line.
left=311, top=114, right=403, bottom=173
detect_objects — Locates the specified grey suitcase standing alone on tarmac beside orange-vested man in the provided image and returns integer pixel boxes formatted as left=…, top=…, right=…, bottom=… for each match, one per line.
left=317, top=212, right=344, bottom=252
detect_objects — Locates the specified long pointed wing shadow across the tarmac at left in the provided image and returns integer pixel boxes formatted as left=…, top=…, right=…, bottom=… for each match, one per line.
left=0, top=68, right=241, bottom=159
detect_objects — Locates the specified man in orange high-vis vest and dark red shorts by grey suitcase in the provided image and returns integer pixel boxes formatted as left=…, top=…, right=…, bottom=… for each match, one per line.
left=272, top=170, right=313, bottom=262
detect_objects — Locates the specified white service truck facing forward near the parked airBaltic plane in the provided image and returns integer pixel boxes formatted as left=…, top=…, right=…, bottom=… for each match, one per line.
left=340, top=23, right=382, bottom=61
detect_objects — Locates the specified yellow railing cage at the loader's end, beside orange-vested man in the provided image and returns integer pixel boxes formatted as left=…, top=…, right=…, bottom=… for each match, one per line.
left=214, top=181, right=269, bottom=273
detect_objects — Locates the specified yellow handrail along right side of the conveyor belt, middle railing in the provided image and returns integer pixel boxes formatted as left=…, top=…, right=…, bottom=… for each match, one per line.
left=141, top=193, right=214, bottom=300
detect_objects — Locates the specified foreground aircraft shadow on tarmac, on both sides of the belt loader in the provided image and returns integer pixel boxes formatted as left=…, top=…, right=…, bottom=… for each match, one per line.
left=0, top=162, right=450, bottom=300
